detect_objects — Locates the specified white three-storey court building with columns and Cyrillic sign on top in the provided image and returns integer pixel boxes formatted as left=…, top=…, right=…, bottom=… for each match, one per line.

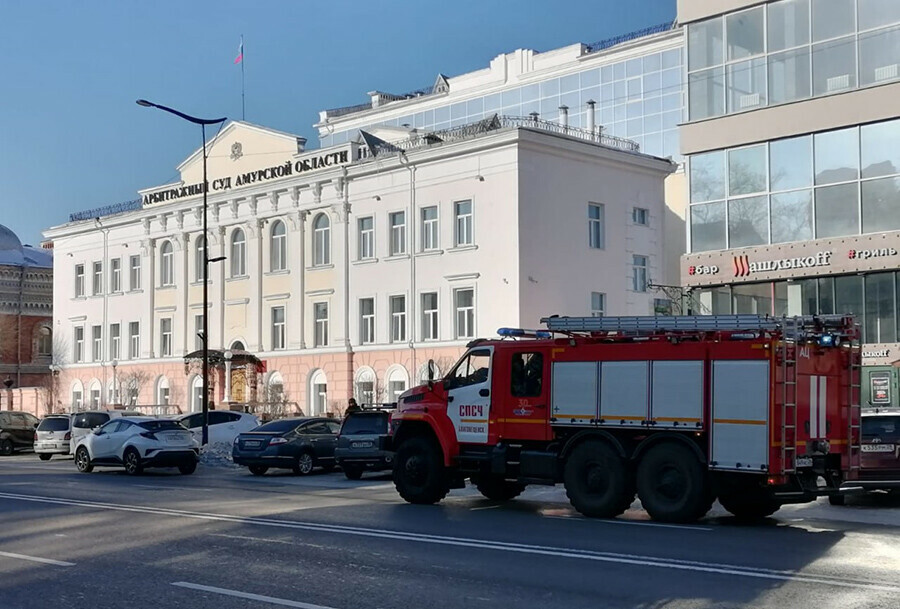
left=46, top=32, right=683, bottom=413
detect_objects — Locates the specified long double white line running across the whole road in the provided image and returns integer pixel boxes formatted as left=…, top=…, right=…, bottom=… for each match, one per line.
left=0, top=493, right=900, bottom=594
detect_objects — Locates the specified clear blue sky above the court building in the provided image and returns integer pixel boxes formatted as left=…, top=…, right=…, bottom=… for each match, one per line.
left=0, top=0, right=675, bottom=244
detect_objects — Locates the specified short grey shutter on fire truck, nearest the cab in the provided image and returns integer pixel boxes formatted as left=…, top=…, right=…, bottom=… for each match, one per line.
left=550, top=362, right=598, bottom=425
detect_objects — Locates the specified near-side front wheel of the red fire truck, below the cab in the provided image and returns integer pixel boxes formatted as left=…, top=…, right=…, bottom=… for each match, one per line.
left=394, top=437, right=450, bottom=505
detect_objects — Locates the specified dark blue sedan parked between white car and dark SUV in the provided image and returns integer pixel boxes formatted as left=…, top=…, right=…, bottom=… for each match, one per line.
left=231, top=417, right=341, bottom=476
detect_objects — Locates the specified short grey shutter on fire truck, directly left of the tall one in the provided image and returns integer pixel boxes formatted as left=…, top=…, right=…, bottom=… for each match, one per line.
left=650, top=360, right=703, bottom=429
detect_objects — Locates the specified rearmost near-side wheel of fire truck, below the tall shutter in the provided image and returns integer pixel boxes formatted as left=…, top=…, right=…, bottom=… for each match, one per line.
left=637, top=443, right=712, bottom=522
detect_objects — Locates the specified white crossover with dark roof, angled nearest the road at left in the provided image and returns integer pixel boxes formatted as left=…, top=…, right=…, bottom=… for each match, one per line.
left=75, top=417, right=200, bottom=475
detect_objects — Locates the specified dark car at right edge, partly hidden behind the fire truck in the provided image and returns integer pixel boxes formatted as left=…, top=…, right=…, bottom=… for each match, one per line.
left=828, top=408, right=900, bottom=505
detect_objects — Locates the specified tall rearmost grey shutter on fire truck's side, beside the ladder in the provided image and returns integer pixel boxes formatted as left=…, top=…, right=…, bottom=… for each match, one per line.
left=710, top=360, right=770, bottom=472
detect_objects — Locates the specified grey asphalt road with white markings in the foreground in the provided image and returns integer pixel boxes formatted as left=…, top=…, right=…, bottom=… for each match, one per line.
left=0, top=455, right=900, bottom=609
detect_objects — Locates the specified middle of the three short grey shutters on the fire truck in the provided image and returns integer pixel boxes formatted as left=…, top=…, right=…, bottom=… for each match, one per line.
left=600, top=361, right=650, bottom=427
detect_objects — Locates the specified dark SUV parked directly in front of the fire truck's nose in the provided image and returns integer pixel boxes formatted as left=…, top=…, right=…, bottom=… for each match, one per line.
left=334, top=407, right=394, bottom=480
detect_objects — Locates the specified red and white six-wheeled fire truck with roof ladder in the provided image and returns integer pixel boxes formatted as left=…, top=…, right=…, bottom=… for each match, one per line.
left=392, top=315, right=861, bottom=522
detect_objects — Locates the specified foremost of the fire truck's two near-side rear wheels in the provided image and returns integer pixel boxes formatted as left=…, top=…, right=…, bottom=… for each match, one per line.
left=563, top=440, right=634, bottom=518
